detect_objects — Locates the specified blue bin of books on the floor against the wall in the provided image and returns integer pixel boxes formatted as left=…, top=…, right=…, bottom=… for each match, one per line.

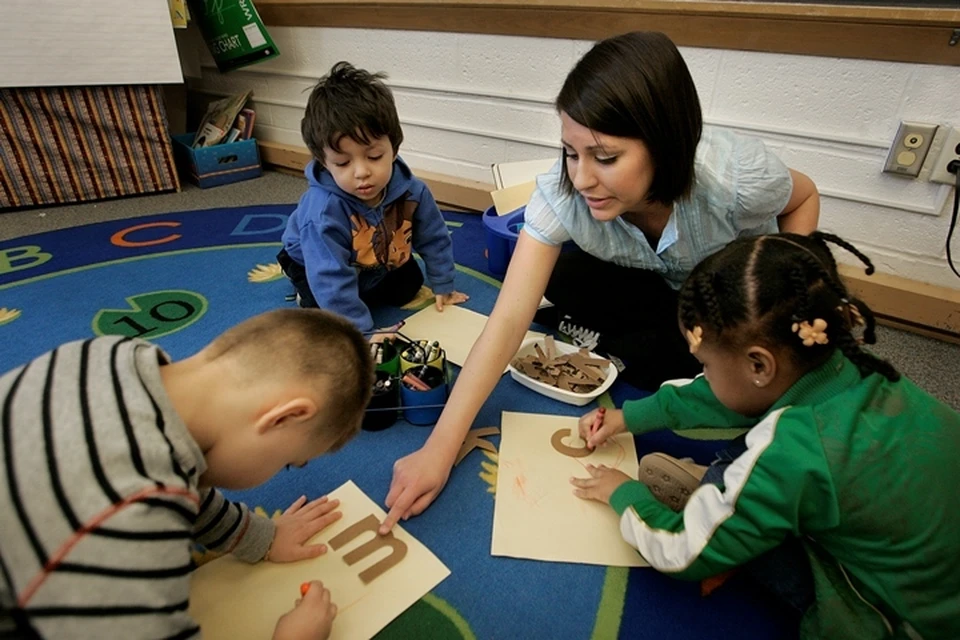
left=173, top=133, right=263, bottom=189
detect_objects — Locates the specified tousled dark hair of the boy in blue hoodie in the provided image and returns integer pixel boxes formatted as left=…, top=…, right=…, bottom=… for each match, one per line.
left=300, top=62, right=403, bottom=163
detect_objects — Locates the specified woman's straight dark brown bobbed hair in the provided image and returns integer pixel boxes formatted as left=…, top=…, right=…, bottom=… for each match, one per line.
left=556, top=31, right=703, bottom=205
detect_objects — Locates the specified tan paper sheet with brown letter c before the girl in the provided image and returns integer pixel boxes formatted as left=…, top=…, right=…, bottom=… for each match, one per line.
left=491, top=411, right=647, bottom=567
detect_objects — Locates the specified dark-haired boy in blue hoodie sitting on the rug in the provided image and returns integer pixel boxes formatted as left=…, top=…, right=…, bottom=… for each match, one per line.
left=277, top=62, right=467, bottom=333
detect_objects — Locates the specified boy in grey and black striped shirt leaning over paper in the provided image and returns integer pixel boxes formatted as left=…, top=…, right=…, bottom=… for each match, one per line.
left=0, top=309, right=373, bottom=639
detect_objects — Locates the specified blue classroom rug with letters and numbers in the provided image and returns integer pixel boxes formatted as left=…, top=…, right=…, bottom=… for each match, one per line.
left=0, top=204, right=796, bottom=640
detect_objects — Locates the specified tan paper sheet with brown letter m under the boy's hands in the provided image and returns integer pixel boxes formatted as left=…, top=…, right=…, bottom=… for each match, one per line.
left=190, top=481, right=450, bottom=640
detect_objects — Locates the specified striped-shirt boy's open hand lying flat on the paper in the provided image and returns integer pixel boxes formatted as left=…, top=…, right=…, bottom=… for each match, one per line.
left=266, top=496, right=343, bottom=562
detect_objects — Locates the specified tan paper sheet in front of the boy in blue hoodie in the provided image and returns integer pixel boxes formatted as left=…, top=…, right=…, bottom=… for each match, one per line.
left=400, top=305, right=543, bottom=371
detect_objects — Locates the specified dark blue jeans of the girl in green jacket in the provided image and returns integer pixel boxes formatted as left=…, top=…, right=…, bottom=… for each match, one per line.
left=700, top=434, right=815, bottom=613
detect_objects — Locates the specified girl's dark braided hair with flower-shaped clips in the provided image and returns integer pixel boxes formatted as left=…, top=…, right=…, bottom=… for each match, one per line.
left=678, top=231, right=900, bottom=381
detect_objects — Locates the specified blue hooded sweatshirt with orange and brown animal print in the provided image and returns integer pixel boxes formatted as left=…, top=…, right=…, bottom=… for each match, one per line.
left=283, top=157, right=455, bottom=331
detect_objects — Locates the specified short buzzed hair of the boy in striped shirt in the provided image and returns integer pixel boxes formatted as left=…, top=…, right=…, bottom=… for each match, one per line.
left=208, top=309, right=374, bottom=451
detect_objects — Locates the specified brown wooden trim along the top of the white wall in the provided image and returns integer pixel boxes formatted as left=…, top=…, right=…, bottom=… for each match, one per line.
left=257, top=0, right=960, bottom=65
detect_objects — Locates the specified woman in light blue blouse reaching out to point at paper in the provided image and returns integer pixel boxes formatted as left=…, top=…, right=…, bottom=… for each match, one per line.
left=381, top=32, right=820, bottom=533
